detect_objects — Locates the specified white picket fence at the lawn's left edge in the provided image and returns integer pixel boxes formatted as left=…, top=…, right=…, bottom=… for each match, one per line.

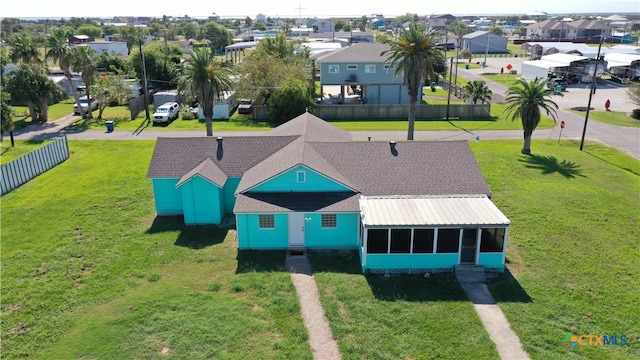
left=0, top=136, right=69, bottom=195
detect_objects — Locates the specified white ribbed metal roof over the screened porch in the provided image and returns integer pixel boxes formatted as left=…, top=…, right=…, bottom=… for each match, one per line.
left=360, top=195, right=509, bottom=226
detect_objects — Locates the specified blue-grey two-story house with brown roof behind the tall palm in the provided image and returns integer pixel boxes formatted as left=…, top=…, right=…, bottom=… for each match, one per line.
left=315, top=43, right=409, bottom=104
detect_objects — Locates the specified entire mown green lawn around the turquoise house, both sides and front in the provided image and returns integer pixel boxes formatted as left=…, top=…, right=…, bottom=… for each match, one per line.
left=0, top=140, right=640, bottom=359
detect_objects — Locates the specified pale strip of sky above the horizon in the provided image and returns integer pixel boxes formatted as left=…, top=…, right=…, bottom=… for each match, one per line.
left=5, top=0, right=640, bottom=18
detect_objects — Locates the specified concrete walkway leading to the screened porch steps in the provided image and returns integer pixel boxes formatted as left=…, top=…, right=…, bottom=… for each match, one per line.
left=460, top=282, right=529, bottom=360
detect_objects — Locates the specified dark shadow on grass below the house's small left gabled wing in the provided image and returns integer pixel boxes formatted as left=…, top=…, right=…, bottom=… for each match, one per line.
left=147, top=216, right=229, bottom=250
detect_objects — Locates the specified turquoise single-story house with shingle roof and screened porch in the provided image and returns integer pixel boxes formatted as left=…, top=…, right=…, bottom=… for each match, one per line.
left=147, top=113, right=509, bottom=273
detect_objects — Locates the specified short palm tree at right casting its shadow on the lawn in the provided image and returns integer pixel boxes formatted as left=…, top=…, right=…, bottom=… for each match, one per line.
left=505, top=78, right=562, bottom=155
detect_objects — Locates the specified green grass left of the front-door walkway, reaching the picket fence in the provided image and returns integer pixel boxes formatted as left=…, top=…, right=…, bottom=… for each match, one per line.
left=0, top=141, right=312, bottom=359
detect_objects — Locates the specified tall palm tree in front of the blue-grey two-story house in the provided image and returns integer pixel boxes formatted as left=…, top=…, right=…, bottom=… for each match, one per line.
left=380, top=24, right=444, bottom=140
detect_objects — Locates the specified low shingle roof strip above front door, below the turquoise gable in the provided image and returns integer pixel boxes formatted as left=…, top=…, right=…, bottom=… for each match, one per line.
left=233, top=192, right=360, bottom=213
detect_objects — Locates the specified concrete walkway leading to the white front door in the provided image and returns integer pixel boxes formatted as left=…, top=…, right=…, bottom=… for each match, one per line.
left=286, top=256, right=340, bottom=360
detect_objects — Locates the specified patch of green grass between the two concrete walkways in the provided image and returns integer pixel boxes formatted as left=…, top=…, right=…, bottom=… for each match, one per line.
left=310, top=252, right=498, bottom=359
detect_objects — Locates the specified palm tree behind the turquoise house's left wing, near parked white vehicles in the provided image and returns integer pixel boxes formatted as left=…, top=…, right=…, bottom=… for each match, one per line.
left=177, top=48, right=232, bottom=136
